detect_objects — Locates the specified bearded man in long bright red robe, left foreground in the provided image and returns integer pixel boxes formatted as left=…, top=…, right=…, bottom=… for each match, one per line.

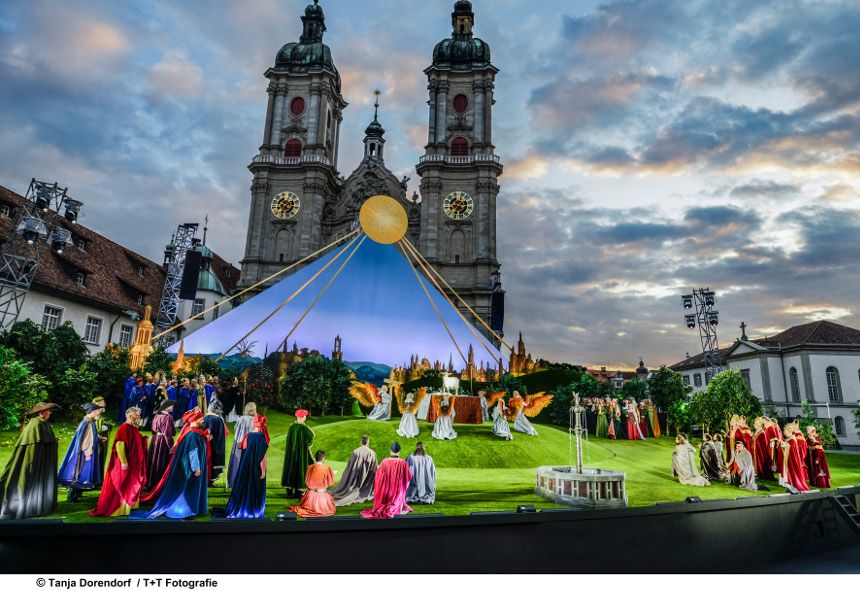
left=90, top=406, right=146, bottom=517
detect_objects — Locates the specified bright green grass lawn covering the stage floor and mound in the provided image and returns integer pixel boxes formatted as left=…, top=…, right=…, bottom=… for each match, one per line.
left=0, top=411, right=860, bottom=521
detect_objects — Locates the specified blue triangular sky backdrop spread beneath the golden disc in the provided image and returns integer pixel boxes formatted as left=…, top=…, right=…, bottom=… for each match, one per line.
left=170, top=238, right=501, bottom=368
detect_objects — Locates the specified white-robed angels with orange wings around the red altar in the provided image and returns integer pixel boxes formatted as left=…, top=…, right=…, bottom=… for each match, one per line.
left=351, top=383, right=552, bottom=441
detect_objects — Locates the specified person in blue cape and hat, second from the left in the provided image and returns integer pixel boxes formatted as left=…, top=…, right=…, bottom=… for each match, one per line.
left=57, top=402, right=104, bottom=503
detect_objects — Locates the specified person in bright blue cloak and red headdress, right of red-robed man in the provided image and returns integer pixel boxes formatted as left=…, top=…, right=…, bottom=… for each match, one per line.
left=141, top=410, right=209, bottom=519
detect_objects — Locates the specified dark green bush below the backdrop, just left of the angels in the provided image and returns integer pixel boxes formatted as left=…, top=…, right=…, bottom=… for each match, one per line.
left=278, top=355, right=352, bottom=415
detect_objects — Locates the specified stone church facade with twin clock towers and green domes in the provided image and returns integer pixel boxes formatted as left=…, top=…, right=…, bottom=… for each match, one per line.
left=240, top=0, right=502, bottom=322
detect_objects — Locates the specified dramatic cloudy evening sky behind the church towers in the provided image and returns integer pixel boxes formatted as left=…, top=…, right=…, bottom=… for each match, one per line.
left=0, top=0, right=860, bottom=365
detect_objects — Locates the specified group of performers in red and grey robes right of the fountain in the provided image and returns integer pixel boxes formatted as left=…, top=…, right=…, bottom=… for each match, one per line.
left=672, top=415, right=830, bottom=492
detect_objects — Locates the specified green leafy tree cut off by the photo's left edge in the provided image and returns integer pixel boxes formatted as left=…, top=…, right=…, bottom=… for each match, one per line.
left=0, top=346, right=51, bottom=430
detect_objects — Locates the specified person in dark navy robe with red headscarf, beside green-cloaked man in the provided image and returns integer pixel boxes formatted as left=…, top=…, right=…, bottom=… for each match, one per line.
left=227, top=415, right=269, bottom=519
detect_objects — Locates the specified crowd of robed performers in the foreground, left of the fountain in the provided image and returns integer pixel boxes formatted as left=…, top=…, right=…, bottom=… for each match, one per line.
left=0, top=388, right=436, bottom=519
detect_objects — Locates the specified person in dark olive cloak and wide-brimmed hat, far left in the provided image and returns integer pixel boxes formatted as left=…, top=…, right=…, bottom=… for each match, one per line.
left=0, top=402, right=60, bottom=519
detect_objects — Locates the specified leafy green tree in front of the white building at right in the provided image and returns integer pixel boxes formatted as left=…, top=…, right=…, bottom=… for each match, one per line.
left=689, top=369, right=762, bottom=429
